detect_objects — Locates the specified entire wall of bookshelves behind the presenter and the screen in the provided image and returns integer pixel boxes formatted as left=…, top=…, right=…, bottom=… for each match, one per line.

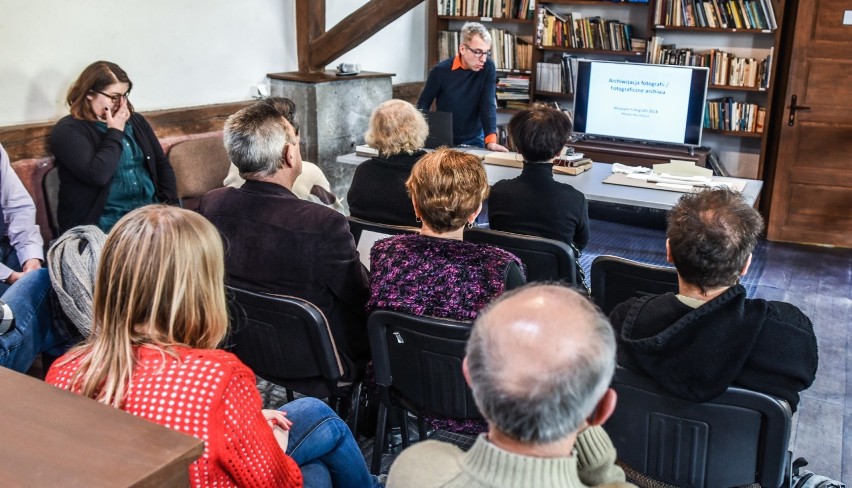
left=427, top=0, right=784, bottom=179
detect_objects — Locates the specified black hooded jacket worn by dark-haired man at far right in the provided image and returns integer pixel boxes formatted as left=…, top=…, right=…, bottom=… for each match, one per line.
left=610, top=285, right=817, bottom=412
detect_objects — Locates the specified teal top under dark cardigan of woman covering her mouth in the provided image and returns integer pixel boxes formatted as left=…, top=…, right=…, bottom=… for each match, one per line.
left=97, top=122, right=157, bottom=233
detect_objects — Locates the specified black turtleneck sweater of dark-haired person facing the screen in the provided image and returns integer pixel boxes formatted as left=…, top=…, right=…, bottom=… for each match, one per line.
left=488, top=162, right=589, bottom=249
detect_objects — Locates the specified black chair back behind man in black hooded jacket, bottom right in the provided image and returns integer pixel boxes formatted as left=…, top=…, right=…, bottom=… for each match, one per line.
left=604, top=368, right=792, bottom=488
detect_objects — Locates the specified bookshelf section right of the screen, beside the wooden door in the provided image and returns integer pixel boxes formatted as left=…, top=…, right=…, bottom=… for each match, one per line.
left=647, top=0, right=784, bottom=178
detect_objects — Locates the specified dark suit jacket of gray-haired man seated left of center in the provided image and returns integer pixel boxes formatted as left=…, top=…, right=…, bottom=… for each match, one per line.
left=203, top=180, right=369, bottom=362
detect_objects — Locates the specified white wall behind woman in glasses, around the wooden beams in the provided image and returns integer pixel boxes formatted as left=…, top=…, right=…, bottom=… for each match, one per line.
left=0, top=0, right=425, bottom=126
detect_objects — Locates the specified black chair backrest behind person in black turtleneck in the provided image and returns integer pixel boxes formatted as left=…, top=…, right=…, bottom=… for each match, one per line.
left=464, top=227, right=581, bottom=285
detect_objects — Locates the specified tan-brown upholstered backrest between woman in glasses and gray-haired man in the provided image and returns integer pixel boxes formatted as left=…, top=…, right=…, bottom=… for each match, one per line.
left=169, top=133, right=231, bottom=209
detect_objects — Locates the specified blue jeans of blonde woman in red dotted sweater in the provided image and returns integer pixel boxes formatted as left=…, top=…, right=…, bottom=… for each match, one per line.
left=279, top=398, right=381, bottom=488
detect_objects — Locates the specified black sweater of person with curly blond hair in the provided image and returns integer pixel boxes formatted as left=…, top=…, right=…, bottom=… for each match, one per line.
left=346, top=151, right=426, bottom=227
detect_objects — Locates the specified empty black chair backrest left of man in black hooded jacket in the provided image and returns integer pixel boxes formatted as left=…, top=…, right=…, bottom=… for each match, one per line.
left=591, top=256, right=678, bottom=315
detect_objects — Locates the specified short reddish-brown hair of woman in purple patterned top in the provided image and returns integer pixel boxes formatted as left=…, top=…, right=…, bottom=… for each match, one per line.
left=405, top=148, right=489, bottom=232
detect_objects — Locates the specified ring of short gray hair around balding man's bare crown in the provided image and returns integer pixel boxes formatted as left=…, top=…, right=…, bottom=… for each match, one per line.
left=467, top=283, right=615, bottom=444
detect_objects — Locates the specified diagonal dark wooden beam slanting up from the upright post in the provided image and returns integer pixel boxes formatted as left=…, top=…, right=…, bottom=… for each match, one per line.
left=308, top=0, right=423, bottom=71
